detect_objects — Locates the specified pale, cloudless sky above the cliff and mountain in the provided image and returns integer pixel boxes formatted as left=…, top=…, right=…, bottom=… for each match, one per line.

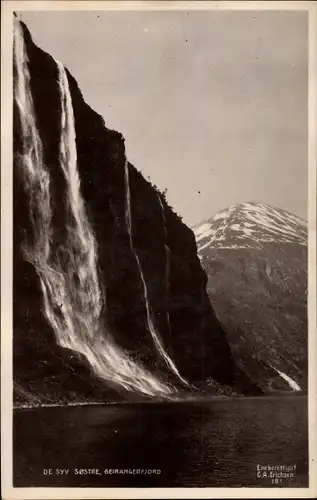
left=20, top=11, right=308, bottom=225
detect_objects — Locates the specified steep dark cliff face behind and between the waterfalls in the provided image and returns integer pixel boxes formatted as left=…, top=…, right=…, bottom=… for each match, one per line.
left=13, top=19, right=256, bottom=402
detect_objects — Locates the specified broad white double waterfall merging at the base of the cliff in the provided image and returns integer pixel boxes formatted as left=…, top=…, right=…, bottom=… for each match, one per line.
left=14, top=20, right=173, bottom=397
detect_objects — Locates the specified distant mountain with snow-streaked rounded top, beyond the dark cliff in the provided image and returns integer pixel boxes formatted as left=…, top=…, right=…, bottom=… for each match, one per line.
left=194, top=203, right=307, bottom=391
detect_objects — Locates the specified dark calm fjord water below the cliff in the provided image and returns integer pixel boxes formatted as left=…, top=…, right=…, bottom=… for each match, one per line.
left=14, top=395, right=308, bottom=487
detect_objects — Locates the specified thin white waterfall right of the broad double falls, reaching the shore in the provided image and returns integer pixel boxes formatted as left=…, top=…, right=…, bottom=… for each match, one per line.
left=124, top=160, right=188, bottom=386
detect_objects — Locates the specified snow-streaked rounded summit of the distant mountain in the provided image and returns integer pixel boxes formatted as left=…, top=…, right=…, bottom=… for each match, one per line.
left=193, top=202, right=307, bottom=252
